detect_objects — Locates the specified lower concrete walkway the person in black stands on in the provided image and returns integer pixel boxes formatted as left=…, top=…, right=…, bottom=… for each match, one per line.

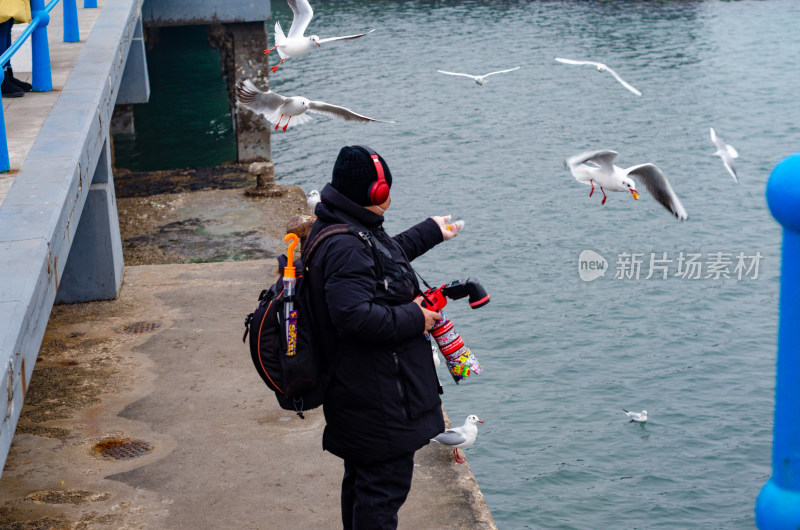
left=0, top=260, right=495, bottom=529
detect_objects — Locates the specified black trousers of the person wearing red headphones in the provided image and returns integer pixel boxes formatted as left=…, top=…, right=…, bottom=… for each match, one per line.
left=342, top=453, right=414, bottom=530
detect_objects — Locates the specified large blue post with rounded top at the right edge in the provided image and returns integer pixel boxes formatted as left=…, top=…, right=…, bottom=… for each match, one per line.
left=755, top=153, right=800, bottom=530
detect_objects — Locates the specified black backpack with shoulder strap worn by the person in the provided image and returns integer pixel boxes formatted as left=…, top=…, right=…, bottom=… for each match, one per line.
left=242, top=224, right=380, bottom=418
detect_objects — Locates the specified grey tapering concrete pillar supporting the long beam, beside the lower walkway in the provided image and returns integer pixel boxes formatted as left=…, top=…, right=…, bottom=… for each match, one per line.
left=55, top=136, right=123, bottom=303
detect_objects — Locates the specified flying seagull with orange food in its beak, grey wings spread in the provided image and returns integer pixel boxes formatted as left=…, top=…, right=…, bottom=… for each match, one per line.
left=566, top=150, right=689, bottom=221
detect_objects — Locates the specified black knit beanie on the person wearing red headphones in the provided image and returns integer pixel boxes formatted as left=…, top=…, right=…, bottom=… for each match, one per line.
left=331, top=145, right=392, bottom=206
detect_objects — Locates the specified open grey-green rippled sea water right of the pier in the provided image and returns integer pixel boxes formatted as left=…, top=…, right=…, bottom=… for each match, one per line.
left=123, top=0, right=800, bottom=528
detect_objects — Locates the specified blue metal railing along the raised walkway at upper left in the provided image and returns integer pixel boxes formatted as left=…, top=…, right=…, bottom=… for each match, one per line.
left=0, top=0, right=97, bottom=173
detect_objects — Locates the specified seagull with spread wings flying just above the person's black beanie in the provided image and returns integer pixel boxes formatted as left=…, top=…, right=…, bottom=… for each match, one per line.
left=236, top=79, right=394, bottom=132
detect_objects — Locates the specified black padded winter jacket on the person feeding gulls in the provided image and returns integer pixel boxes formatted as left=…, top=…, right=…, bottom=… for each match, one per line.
left=304, top=184, right=444, bottom=463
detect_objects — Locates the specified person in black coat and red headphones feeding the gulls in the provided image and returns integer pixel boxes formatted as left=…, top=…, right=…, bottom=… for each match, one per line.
left=304, top=146, right=462, bottom=529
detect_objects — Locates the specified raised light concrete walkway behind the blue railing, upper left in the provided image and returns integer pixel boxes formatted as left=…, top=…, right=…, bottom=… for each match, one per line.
left=0, top=0, right=106, bottom=204
